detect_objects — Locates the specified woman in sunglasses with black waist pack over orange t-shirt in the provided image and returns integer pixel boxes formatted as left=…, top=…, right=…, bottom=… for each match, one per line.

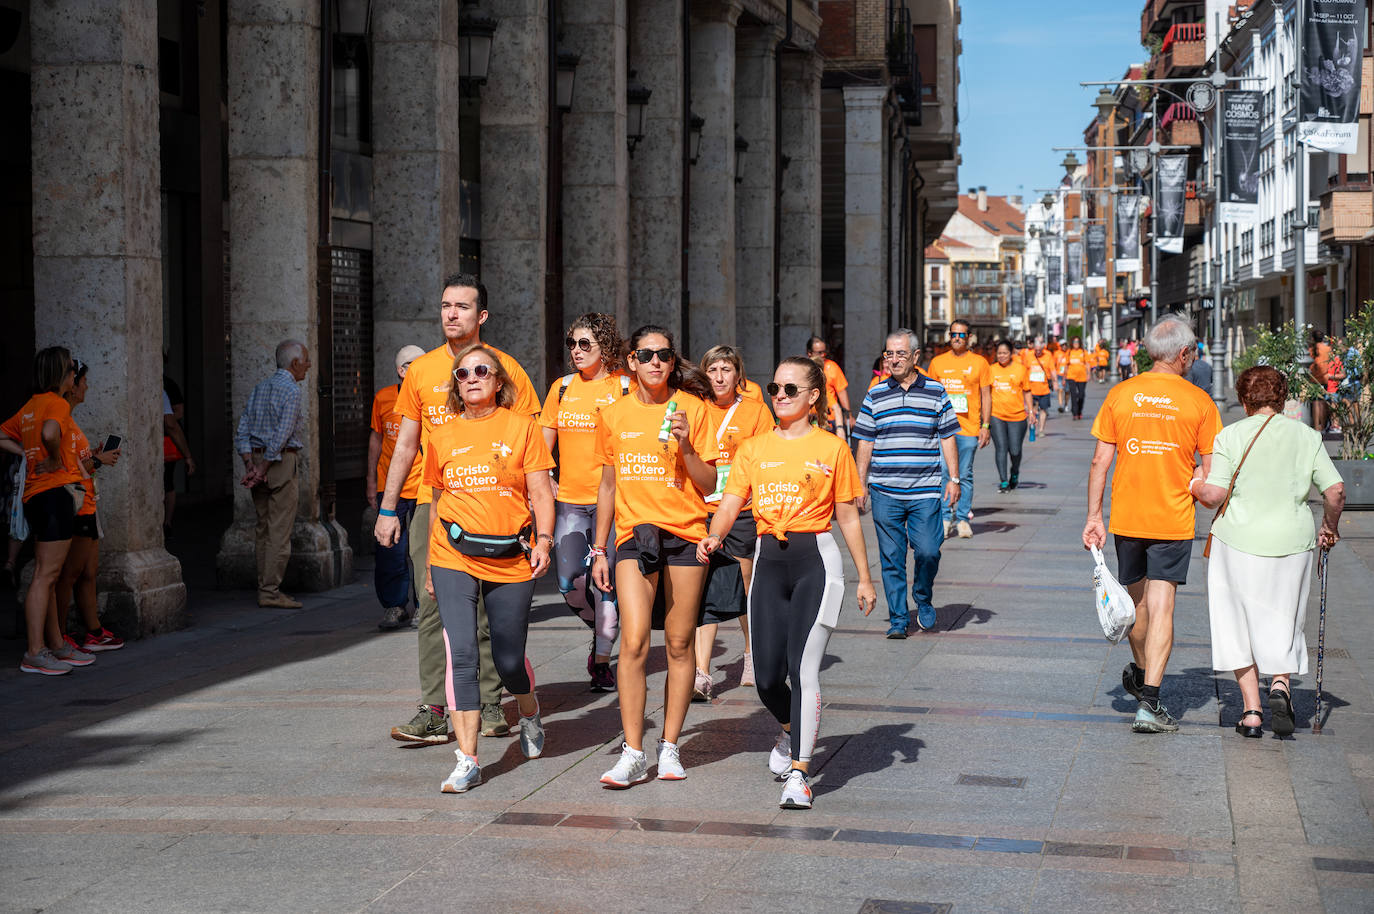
left=423, top=344, right=554, bottom=793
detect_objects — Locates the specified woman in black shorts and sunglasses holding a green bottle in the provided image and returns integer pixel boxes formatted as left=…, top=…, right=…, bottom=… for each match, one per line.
left=591, top=326, right=716, bottom=788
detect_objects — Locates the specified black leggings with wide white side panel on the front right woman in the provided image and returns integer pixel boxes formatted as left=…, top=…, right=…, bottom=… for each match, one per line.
left=749, top=532, right=845, bottom=761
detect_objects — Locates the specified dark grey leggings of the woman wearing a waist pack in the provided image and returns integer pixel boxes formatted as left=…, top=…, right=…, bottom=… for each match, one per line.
left=430, top=565, right=534, bottom=711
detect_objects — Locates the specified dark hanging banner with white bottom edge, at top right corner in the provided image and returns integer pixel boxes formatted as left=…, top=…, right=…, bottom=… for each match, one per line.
left=1297, top=0, right=1364, bottom=154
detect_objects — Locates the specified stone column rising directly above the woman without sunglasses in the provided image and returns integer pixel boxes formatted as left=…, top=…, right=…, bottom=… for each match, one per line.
left=683, top=0, right=739, bottom=359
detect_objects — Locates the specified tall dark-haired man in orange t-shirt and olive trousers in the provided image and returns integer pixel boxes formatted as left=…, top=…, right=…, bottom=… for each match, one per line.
left=374, top=274, right=540, bottom=744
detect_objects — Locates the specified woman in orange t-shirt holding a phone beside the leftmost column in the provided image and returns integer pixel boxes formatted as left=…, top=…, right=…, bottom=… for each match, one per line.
left=54, top=359, right=124, bottom=654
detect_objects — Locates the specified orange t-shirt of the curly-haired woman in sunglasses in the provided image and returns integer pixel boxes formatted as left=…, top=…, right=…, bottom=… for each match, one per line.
left=539, top=374, right=632, bottom=504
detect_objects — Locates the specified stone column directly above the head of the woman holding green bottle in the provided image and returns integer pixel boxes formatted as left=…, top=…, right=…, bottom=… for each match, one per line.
left=622, top=0, right=687, bottom=339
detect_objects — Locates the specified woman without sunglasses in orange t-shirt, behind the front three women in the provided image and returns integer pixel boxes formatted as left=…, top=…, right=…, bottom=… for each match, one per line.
left=691, top=346, right=774, bottom=701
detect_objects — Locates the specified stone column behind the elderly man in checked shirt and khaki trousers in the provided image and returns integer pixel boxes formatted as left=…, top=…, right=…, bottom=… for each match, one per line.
left=216, top=0, right=353, bottom=591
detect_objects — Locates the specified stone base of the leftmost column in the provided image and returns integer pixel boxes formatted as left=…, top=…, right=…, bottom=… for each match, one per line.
left=96, top=546, right=185, bottom=638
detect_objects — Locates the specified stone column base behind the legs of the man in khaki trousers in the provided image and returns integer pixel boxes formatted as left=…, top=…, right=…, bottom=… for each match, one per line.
left=214, top=520, right=353, bottom=594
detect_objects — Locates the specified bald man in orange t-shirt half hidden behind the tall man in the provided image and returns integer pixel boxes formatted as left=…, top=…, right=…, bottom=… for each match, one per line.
left=365, top=346, right=425, bottom=631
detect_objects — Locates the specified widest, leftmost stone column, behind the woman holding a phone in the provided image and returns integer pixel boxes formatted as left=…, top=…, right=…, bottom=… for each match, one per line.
left=30, top=0, right=185, bottom=636
